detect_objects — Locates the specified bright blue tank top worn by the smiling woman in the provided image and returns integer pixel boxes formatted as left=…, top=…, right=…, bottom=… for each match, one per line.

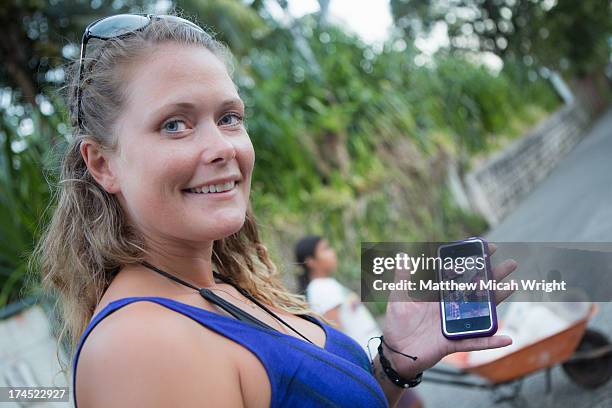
left=72, top=296, right=389, bottom=408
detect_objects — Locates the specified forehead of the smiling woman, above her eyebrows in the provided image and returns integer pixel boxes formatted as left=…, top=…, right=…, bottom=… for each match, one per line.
left=121, top=43, right=238, bottom=110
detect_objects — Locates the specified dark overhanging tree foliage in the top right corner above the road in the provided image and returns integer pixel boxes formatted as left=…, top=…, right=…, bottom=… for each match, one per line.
left=390, top=0, right=612, bottom=76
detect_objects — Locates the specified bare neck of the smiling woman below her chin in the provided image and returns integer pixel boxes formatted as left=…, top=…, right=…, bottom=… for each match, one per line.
left=144, top=234, right=215, bottom=288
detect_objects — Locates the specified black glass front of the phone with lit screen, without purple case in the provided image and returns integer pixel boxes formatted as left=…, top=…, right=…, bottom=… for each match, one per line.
left=439, top=240, right=492, bottom=333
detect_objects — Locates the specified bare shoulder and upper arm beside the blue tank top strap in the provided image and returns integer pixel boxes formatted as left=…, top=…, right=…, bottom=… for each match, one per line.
left=75, top=301, right=243, bottom=408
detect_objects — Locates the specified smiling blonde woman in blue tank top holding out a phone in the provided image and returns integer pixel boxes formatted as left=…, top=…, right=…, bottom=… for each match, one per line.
left=35, top=11, right=511, bottom=407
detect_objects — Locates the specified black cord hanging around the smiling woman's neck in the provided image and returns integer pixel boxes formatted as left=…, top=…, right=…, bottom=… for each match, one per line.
left=140, top=261, right=314, bottom=344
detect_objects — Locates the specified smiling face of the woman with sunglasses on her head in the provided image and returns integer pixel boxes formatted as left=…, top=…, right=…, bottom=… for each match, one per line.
left=110, top=43, right=255, bottom=242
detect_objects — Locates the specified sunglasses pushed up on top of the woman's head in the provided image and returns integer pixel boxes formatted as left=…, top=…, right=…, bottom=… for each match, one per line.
left=76, top=13, right=205, bottom=129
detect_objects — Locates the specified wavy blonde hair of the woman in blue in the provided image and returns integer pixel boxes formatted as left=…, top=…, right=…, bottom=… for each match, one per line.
left=29, top=12, right=316, bottom=368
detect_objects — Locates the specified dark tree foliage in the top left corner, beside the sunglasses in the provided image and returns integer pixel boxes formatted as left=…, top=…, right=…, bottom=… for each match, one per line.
left=0, top=0, right=154, bottom=106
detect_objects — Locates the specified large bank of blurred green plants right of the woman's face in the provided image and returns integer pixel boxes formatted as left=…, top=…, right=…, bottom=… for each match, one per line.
left=241, top=16, right=559, bottom=283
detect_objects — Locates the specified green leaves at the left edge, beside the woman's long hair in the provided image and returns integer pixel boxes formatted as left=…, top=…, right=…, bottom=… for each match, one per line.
left=0, top=105, right=61, bottom=306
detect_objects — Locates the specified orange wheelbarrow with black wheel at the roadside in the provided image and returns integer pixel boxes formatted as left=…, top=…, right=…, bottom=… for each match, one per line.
left=423, top=304, right=612, bottom=402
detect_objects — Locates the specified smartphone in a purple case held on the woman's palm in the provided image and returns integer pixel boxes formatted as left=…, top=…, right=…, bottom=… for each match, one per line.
left=438, top=237, right=497, bottom=340
